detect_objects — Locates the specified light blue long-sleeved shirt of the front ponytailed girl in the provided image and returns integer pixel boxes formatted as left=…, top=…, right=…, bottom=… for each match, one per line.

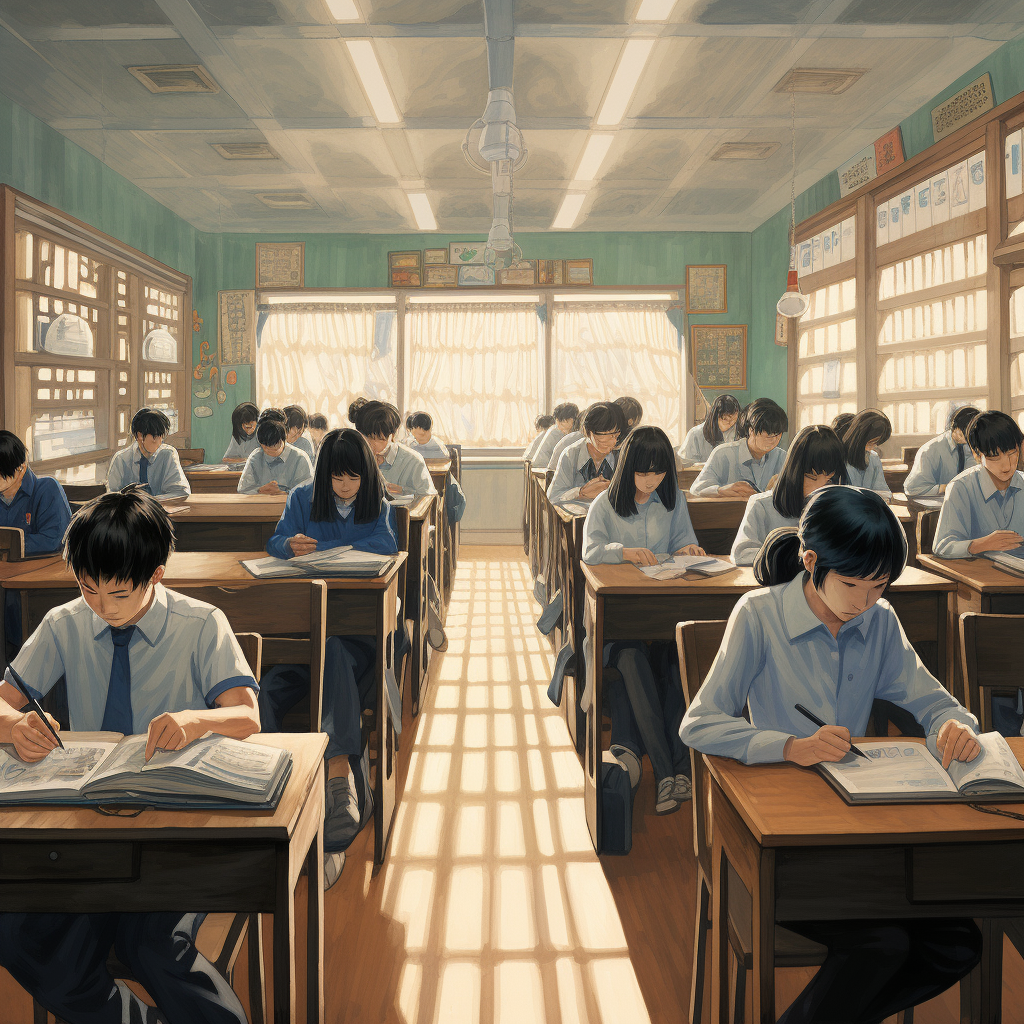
left=679, top=572, right=978, bottom=764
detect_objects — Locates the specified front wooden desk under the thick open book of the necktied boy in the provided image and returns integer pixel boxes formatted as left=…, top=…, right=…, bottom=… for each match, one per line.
left=0, top=733, right=327, bottom=1024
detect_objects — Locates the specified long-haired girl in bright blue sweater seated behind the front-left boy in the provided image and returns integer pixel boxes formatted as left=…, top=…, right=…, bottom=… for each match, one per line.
left=259, top=429, right=398, bottom=889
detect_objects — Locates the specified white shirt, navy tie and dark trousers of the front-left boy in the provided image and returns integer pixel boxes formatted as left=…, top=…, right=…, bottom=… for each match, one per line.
left=0, top=584, right=259, bottom=1024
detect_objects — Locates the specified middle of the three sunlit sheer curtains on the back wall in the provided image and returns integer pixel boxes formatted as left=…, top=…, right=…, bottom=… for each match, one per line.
left=406, top=302, right=544, bottom=447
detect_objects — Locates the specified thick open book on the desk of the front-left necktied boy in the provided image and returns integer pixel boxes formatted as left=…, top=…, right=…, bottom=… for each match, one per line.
left=0, top=732, right=292, bottom=807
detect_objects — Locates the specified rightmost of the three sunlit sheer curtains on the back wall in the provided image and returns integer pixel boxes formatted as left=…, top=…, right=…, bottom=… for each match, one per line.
left=552, top=301, right=683, bottom=444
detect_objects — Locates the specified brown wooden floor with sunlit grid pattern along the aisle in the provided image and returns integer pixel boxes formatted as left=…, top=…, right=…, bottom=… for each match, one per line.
left=6, top=546, right=1024, bottom=1024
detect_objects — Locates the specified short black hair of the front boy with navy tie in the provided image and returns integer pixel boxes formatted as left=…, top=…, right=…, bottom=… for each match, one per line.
left=63, top=483, right=174, bottom=587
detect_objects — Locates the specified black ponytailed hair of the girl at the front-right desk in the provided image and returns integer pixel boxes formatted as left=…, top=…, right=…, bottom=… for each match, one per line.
left=754, top=484, right=906, bottom=590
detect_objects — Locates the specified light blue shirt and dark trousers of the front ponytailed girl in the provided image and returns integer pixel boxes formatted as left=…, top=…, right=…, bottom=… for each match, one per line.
left=680, top=572, right=981, bottom=1024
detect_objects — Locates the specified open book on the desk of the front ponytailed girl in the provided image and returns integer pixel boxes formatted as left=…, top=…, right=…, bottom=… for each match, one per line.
left=817, top=732, right=1024, bottom=804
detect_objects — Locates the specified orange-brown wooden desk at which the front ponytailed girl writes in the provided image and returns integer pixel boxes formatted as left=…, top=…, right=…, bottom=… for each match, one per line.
left=703, top=737, right=1024, bottom=1024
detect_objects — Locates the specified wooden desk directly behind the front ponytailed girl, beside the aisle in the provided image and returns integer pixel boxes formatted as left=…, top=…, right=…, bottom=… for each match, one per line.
left=582, top=563, right=954, bottom=848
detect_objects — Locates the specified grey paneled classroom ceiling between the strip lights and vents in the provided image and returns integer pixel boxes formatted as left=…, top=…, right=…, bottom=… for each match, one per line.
left=0, top=0, right=1024, bottom=233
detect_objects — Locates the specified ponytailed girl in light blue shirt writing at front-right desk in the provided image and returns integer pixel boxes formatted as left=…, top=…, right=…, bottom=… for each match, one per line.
left=680, top=486, right=981, bottom=1024
